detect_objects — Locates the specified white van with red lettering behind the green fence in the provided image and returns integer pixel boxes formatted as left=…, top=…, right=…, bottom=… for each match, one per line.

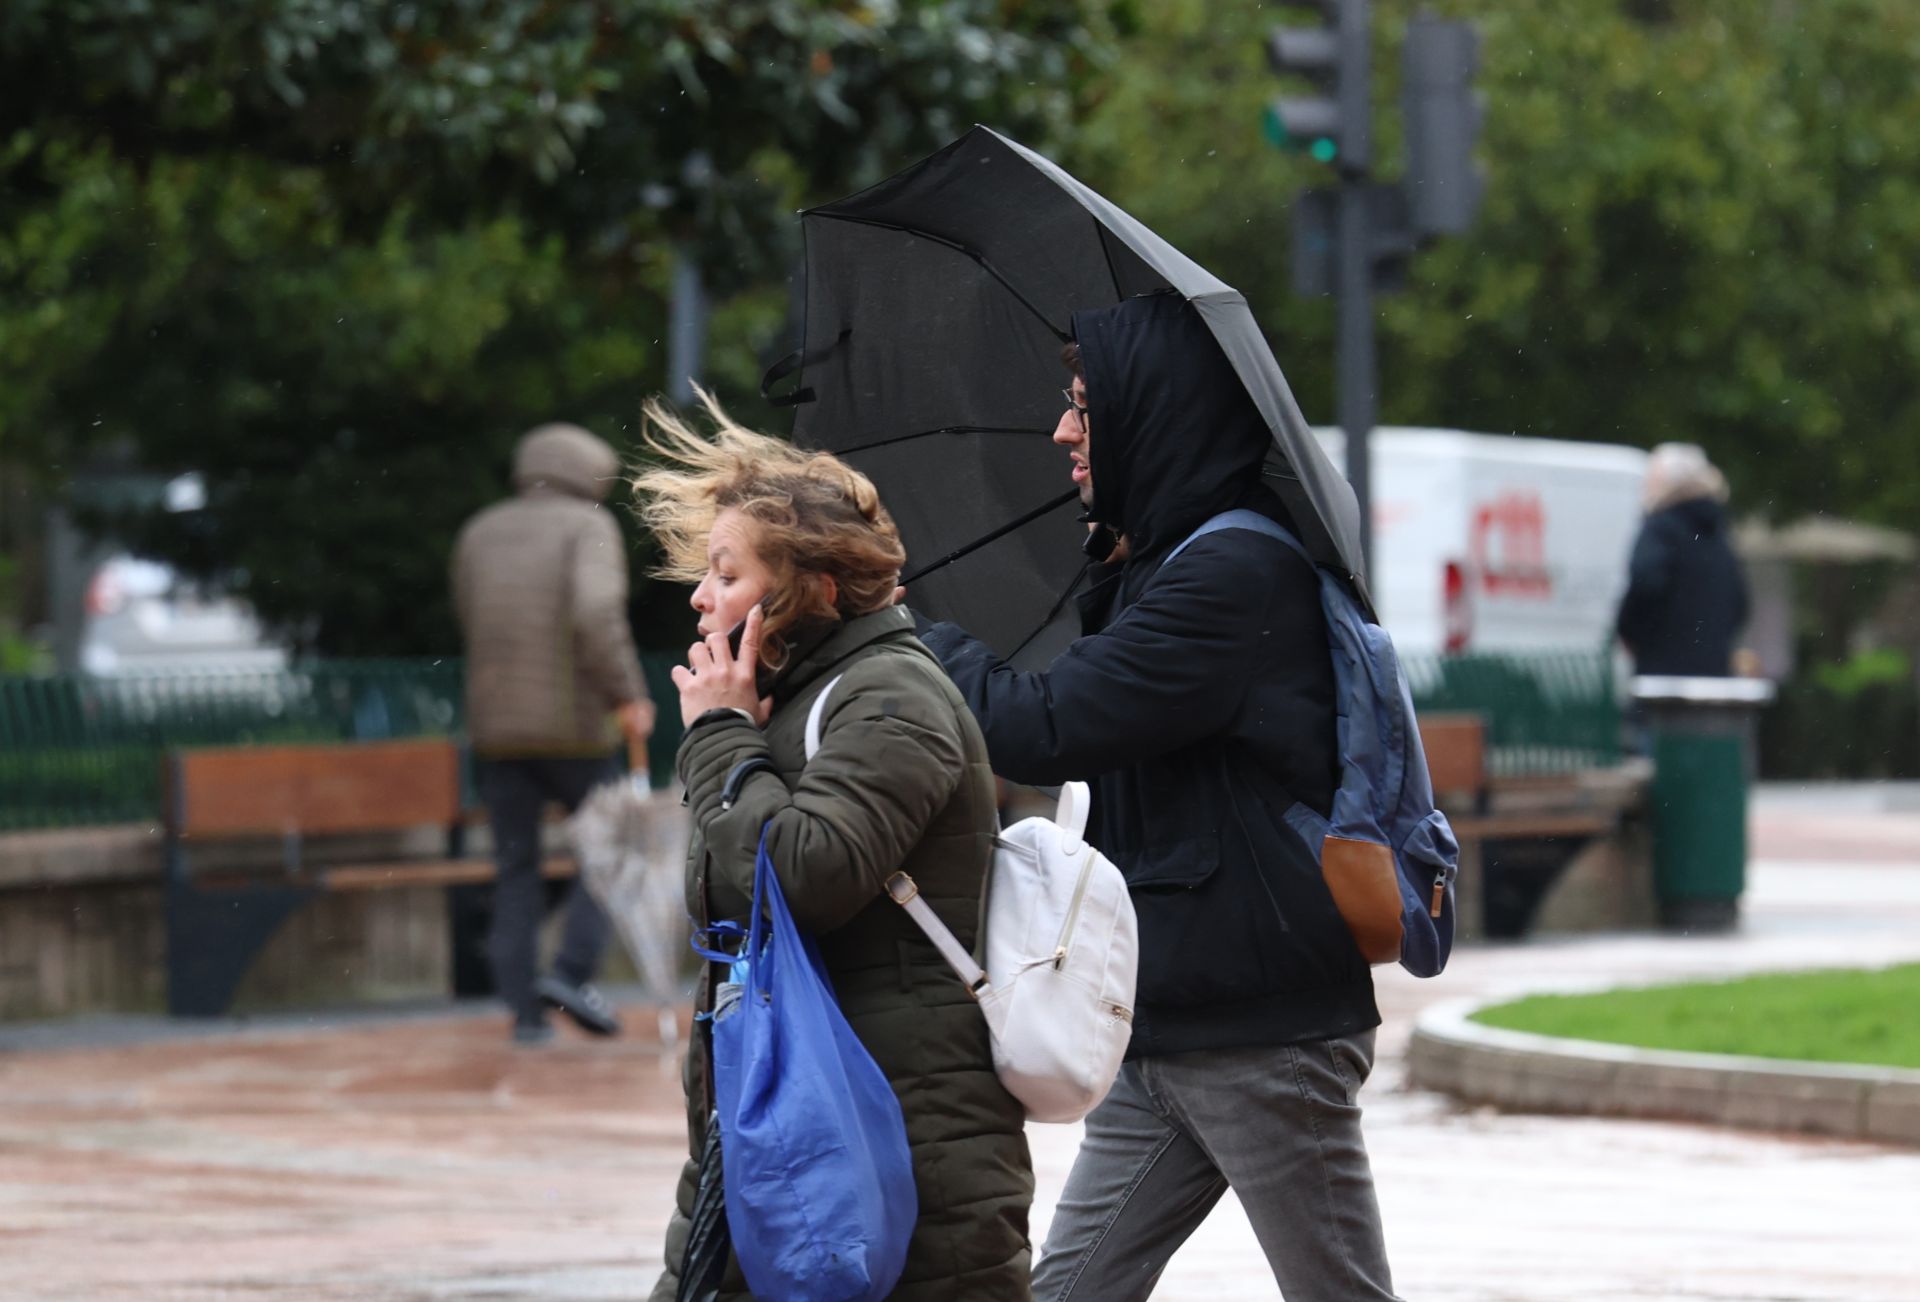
left=1315, top=426, right=1647, bottom=655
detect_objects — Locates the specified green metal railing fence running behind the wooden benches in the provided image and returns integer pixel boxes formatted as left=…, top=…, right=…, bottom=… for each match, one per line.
left=0, top=655, right=1620, bottom=832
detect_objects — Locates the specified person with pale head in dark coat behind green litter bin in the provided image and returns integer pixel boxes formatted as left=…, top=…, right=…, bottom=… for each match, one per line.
left=1617, top=444, right=1747, bottom=678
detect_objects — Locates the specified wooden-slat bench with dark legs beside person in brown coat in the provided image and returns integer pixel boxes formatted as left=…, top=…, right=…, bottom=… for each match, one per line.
left=165, top=739, right=574, bottom=1016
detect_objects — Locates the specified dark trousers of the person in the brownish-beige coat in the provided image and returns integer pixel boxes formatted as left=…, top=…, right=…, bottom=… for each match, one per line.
left=478, top=759, right=620, bottom=1022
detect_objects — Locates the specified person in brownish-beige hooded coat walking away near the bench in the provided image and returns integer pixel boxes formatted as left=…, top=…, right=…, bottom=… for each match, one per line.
left=453, top=424, right=653, bottom=1045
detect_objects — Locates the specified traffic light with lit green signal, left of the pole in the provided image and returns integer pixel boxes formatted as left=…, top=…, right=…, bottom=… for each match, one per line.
left=1265, top=0, right=1369, bottom=171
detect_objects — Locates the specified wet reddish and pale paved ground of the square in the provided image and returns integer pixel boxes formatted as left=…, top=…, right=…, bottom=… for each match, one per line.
left=0, top=789, right=1920, bottom=1302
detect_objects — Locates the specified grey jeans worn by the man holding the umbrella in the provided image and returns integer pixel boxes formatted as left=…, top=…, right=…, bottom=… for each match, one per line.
left=1033, top=1031, right=1394, bottom=1302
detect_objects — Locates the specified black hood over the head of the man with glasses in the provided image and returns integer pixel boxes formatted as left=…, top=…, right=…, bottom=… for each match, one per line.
left=1073, top=294, right=1273, bottom=561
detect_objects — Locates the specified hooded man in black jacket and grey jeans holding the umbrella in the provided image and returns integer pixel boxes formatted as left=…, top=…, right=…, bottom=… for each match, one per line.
left=922, top=294, right=1394, bottom=1302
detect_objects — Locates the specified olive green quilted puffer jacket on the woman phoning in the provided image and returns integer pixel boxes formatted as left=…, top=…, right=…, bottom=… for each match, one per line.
left=653, top=609, right=1033, bottom=1302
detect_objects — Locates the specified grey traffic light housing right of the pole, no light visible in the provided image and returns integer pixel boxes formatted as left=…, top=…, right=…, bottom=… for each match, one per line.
left=1400, top=17, right=1486, bottom=236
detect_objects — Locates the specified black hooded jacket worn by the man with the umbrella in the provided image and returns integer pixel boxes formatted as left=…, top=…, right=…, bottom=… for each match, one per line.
left=922, top=294, right=1379, bottom=1056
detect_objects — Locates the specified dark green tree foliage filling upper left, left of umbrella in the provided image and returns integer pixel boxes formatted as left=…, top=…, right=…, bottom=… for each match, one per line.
left=0, top=0, right=1108, bottom=653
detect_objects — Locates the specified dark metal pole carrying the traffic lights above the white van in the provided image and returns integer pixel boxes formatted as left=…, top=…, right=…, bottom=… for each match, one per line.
left=1334, top=0, right=1379, bottom=576
